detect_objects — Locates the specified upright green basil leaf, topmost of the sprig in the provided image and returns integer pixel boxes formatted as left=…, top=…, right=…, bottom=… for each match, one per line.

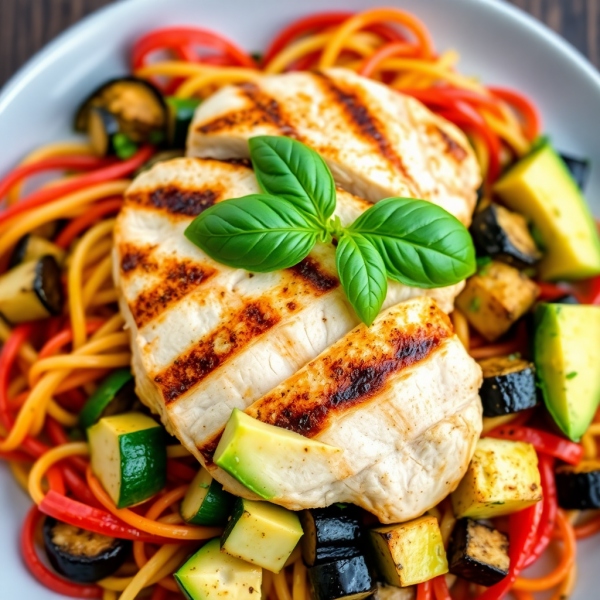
left=249, top=135, right=336, bottom=224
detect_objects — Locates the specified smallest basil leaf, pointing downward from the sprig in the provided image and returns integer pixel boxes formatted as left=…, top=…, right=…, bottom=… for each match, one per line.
left=335, top=231, right=387, bottom=325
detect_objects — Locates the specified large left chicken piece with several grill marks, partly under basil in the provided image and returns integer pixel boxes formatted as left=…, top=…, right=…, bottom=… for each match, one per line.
left=114, top=158, right=462, bottom=480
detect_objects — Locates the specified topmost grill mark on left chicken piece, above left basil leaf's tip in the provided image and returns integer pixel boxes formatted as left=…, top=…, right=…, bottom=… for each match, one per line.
left=127, top=184, right=222, bottom=217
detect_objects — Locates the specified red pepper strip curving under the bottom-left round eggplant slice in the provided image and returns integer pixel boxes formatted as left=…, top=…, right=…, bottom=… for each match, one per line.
left=21, top=506, right=102, bottom=598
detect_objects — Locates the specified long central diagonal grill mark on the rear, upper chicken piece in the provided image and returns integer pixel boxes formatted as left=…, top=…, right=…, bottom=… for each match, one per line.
left=315, top=73, right=415, bottom=185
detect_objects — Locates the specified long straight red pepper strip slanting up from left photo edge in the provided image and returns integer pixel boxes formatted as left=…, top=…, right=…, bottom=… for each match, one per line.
left=0, top=146, right=154, bottom=230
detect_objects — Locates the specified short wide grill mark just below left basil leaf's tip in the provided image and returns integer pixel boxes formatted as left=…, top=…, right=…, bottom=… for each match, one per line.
left=129, top=258, right=217, bottom=328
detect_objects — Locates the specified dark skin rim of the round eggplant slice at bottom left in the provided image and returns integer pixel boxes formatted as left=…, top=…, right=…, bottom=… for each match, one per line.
left=43, top=517, right=131, bottom=583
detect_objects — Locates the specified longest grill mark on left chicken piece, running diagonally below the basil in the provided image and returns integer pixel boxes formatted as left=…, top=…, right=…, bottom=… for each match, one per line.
left=154, top=299, right=281, bottom=404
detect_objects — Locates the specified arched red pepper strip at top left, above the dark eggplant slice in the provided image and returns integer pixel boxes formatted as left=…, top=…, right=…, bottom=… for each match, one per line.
left=132, top=27, right=258, bottom=70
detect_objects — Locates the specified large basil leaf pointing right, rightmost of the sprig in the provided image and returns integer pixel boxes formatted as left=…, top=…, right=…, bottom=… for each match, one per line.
left=349, top=198, right=476, bottom=288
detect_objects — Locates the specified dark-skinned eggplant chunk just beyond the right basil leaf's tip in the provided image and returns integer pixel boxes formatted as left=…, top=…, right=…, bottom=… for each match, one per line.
left=471, top=204, right=542, bottom=268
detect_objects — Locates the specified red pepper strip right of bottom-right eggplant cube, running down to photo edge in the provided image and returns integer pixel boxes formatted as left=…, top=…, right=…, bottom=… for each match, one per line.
left=477, top=502, right=543, bottom=600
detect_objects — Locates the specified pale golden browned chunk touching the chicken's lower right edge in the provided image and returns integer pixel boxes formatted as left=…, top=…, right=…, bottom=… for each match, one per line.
left=451, top=438, right=542, bottom=519
